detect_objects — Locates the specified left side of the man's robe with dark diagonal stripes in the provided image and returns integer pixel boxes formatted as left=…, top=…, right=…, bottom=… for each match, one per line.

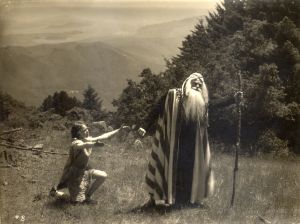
left=146, top=89, right=179, bottom=204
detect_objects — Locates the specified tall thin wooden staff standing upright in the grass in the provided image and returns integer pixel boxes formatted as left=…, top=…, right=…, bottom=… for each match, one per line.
left=230, top=71, right=242, bottom=207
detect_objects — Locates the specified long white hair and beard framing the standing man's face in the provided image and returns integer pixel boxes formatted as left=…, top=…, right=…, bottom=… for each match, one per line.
left=182, top=73, right=208, bottom=122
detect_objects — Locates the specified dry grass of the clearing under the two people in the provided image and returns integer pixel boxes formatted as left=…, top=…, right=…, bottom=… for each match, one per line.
left=0, top=129, right=300, bottom=224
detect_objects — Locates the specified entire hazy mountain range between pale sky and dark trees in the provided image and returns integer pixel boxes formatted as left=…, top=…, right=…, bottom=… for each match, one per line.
left=0, top=17, right=199, bottom=109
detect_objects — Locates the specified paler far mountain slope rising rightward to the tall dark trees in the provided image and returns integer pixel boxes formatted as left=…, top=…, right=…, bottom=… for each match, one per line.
left=102, top=17, right=202, bottom=72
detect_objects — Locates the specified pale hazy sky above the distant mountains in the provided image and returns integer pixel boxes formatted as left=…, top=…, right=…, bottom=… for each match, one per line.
left=0, top=0, right=220, bottom=45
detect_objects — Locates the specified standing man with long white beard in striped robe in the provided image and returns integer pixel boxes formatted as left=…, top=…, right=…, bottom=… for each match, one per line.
left=139, top=73, right=214, bottom=205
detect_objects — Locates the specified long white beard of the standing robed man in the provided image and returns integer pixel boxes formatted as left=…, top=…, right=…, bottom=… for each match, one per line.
left=183, top=83, right=208, bottom=122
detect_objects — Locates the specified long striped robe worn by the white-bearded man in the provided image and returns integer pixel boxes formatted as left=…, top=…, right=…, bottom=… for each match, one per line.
left=146, top=89, right=213, bottom=204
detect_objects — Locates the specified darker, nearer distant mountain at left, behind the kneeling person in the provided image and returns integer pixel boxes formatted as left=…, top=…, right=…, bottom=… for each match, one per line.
left=0, top=42, right=142, bottom=110
